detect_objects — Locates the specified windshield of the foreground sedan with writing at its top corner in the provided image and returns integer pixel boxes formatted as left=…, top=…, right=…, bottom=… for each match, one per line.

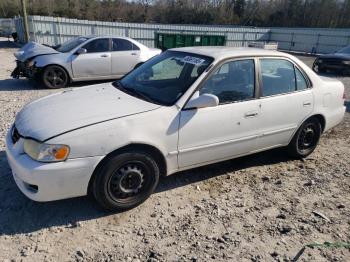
left=113, top=51, right=213, bottom=106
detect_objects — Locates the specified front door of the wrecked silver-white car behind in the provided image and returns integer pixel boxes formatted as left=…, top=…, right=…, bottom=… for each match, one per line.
left=72, top=38, right=111, bottom=79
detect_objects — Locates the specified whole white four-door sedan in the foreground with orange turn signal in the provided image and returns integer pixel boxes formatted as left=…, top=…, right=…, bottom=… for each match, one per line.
left=6, top=47, right=345, bottom=210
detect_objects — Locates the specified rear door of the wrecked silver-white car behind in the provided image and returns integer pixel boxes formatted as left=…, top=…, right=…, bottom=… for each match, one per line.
left=112, top=38, right=141, bottom=78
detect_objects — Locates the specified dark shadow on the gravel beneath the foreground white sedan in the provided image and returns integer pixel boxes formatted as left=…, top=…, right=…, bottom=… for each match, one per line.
left=0, top=147, right=289, bottom=236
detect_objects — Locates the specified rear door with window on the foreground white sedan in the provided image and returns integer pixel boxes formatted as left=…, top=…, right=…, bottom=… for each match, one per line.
left=258, top=58, right=314, bottom=149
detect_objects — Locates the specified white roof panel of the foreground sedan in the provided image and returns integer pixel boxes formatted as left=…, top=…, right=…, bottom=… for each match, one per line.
left=169, top=46, right=289, bottom=59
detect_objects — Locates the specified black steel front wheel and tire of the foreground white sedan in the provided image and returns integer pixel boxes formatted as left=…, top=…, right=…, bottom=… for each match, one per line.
left=92, top=151, right=160, bottom=211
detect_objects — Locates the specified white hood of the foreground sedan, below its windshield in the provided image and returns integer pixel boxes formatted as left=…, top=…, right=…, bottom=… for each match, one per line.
left=15, top=83, right=160, bottom=141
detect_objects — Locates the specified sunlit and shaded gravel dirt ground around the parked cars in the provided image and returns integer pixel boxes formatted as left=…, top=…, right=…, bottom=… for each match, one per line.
left=0, top=37, right=350, bottom=261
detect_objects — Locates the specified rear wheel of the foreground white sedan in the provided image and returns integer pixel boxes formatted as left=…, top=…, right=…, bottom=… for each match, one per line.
left=287, top=117, right=322, bottom=158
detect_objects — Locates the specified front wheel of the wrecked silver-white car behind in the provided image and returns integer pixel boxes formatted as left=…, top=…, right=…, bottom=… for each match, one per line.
left=42, top=65, right=69, bottom=89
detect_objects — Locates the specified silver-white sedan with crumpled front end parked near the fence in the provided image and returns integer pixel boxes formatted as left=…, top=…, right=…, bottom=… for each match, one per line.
left=12, top=36, right=161, bottom=88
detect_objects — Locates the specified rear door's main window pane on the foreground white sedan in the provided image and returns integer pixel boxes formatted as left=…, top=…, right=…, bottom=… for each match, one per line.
left=260, top=59, right=296, bottom=96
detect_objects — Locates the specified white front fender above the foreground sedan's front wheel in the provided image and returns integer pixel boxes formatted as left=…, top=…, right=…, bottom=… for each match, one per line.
left=45, top=107, right=179, bottom=176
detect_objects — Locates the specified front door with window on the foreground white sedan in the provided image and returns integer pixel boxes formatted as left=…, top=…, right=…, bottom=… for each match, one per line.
left=178, top=59, right=259, bottom=168
